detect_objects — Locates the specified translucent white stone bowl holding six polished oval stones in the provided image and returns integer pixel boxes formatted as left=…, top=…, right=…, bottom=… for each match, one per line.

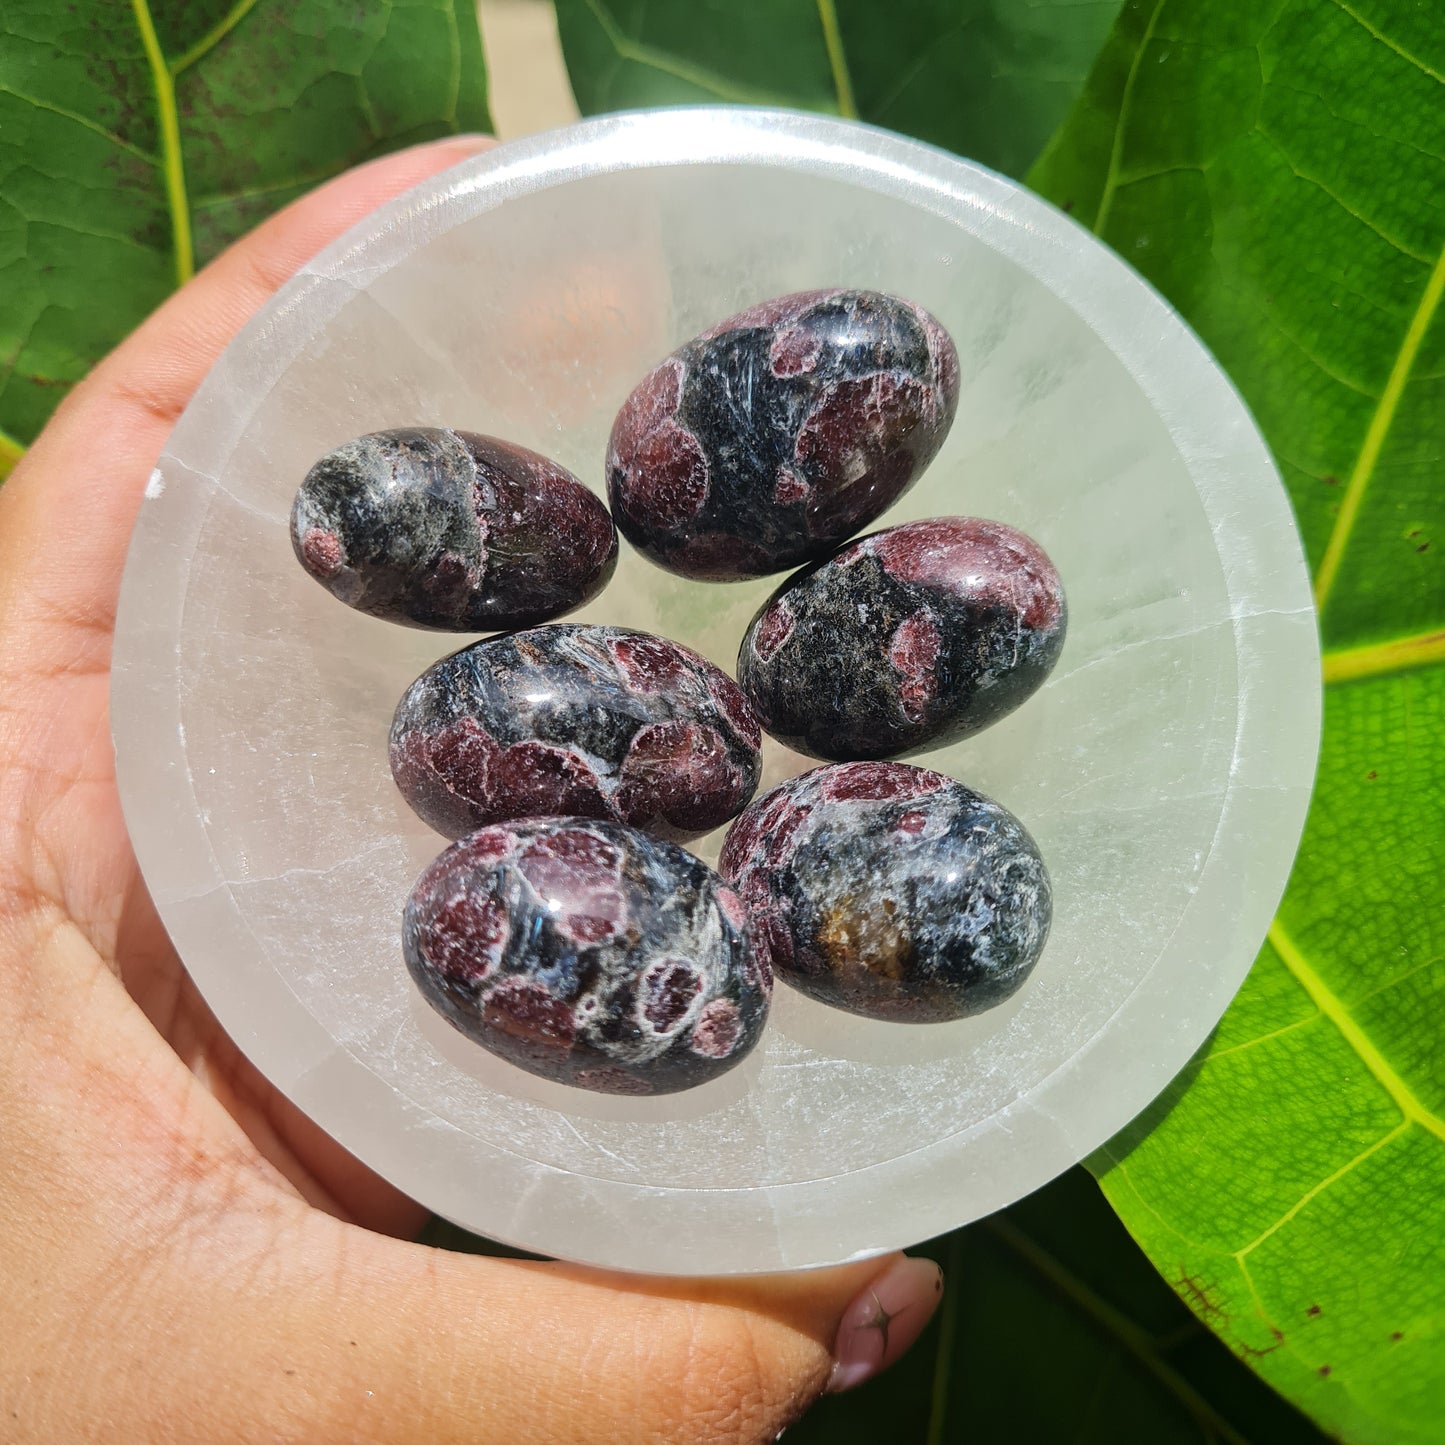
left=113, top=110, right=1319, bottom=1273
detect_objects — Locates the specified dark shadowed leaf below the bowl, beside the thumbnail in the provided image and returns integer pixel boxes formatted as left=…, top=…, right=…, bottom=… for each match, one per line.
left=786, top=1169, right=1324, bottom=1445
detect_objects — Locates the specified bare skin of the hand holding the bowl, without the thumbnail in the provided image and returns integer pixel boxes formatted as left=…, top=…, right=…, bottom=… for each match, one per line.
left=0, top=140, right=901, bottom=1445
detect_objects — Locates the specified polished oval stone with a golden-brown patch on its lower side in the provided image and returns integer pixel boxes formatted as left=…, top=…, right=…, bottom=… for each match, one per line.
left=720, top=763, right=1052, bottom=1023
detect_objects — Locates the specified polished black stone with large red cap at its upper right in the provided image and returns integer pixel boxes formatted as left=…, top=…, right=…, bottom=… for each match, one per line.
left=737, top=517, right=1068, bottom=762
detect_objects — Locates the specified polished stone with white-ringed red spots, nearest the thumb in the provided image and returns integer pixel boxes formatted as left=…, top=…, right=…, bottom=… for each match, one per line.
left=402, top=818, right=772, bottom=1094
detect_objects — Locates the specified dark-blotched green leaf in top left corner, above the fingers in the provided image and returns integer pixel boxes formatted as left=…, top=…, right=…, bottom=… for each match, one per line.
left=0, top=0, right=488, bottom=475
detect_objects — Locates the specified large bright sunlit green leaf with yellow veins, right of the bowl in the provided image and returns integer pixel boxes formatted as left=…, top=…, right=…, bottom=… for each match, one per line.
left=1030, top=0, right=1445, bottom=1445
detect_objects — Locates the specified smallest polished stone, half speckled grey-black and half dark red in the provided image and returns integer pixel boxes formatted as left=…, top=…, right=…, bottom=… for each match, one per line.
left=290, top=426, right=617, bottom=631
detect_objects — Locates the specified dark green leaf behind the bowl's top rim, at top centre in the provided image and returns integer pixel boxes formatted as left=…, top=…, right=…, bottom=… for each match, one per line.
left=556, top=0, right=1120, bottom=175
